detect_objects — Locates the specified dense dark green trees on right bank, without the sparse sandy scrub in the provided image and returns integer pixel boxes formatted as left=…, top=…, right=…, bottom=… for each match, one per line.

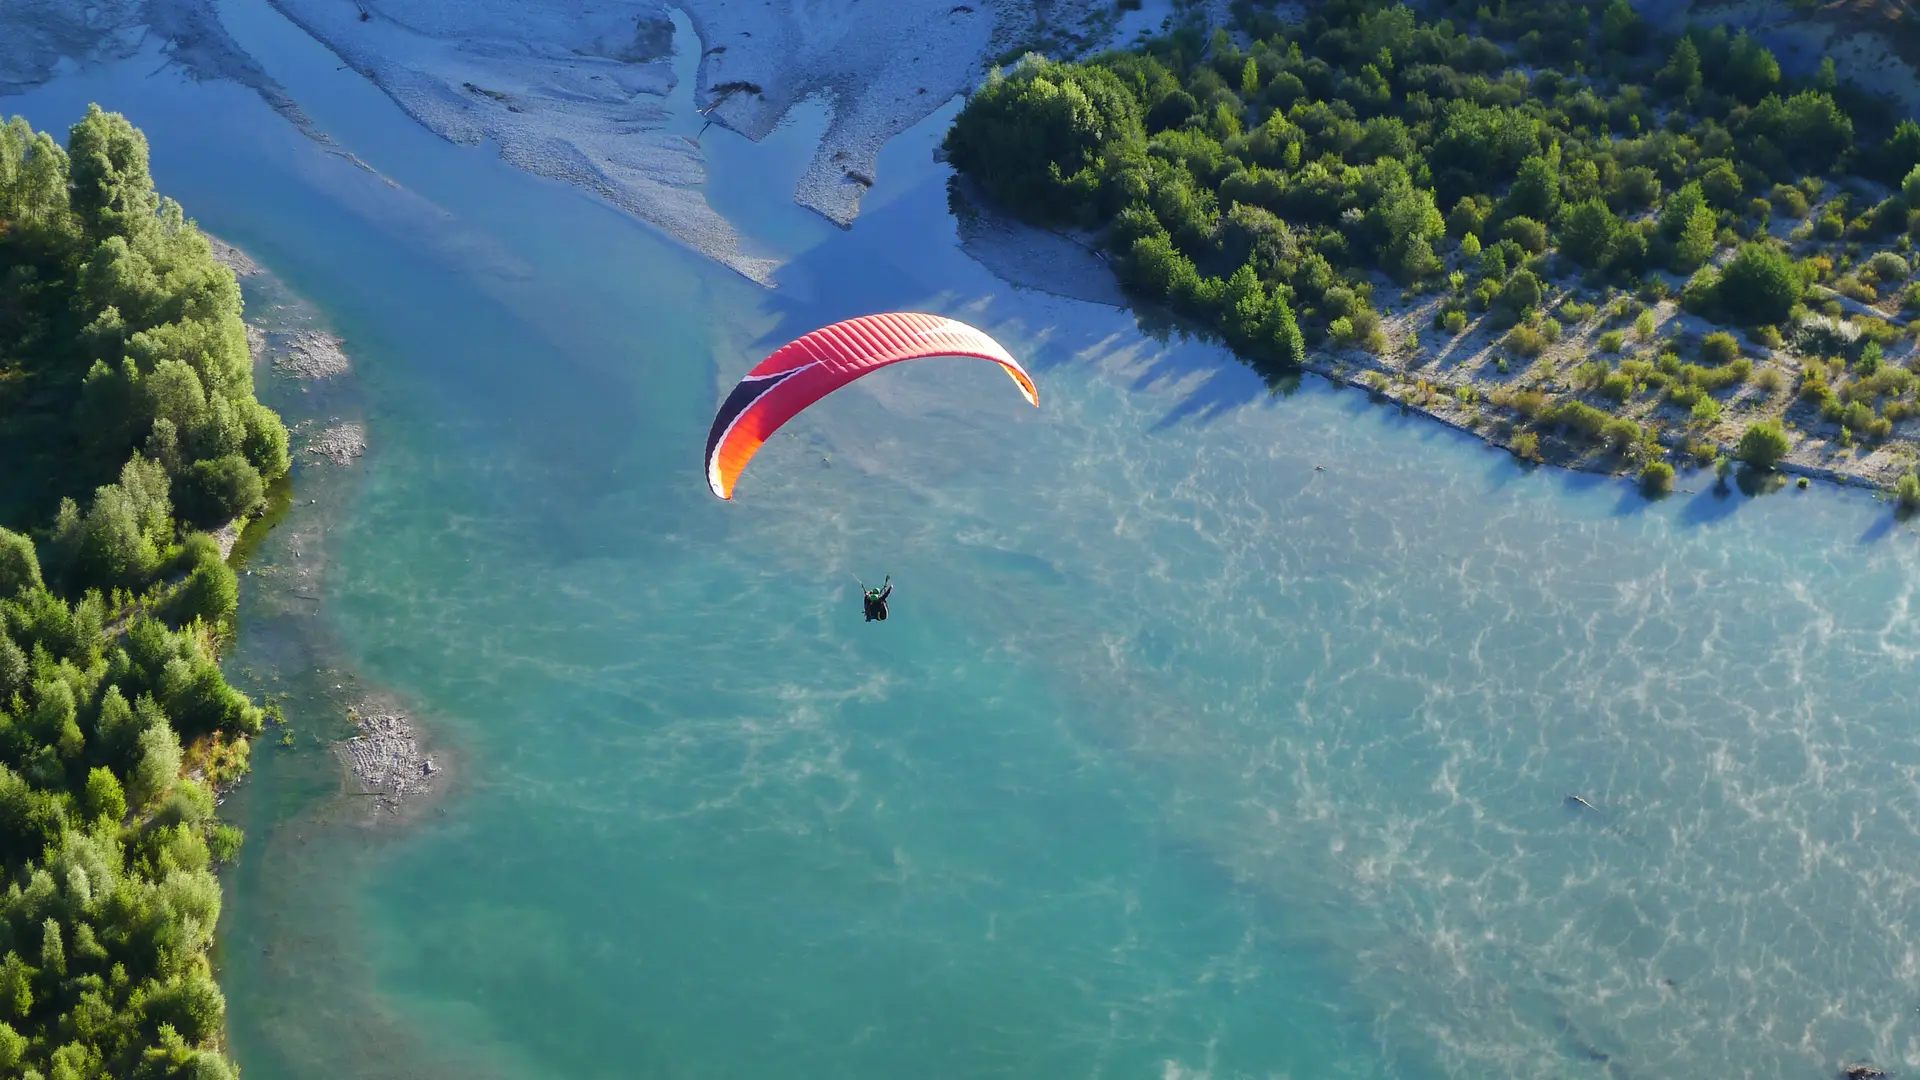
left=947, top=0, right=1920, bottom=367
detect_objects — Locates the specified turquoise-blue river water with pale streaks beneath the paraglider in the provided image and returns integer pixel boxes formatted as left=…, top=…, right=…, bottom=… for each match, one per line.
left=8, top=8, right=1920, bottom=1078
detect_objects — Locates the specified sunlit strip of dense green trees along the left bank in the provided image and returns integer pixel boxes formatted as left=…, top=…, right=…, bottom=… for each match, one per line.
left=0, top=106, right=288, bottom=1080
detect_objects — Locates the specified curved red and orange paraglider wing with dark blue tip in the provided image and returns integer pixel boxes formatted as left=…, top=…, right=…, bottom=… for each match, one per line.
left=707, top=311, right=1041, bottom=500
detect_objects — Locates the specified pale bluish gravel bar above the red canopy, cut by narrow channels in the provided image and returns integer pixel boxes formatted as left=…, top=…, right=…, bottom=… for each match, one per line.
left=251, top=0, right=1108, bottom=282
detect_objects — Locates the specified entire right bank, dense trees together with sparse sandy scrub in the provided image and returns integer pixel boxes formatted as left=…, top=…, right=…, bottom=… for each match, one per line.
left=943, top=0, right=1920, bottom=509
